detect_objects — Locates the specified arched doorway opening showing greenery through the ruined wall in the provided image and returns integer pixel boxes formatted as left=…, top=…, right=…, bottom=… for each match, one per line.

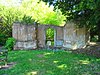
left=46, top=28, right=55, bottom=47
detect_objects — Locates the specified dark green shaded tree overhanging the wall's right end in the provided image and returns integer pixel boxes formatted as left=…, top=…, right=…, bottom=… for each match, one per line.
left=43, top=0, right=100, bottom=41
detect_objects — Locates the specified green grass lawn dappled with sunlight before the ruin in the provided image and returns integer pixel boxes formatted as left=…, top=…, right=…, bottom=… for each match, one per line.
left=0, top=50, right=100, bottom=75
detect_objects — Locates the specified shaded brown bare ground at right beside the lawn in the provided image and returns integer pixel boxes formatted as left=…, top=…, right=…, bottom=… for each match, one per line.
left=72, top=43, right=100, bottom=58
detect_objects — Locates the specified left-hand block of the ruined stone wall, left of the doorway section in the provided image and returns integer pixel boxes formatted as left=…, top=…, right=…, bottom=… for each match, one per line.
left=13, top=23, right=37, bottom=49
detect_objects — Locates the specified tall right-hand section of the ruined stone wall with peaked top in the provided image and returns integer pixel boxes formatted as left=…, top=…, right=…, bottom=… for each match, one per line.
left=63, top=22, right=89, bottom=49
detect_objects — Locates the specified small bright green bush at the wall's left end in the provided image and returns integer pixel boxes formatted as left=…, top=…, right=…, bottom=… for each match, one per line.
left=4, top=38, right=16, bottom=51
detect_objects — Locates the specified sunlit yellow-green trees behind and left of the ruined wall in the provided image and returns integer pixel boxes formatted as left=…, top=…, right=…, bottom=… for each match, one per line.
left=0, top=0, right=65, bottom=44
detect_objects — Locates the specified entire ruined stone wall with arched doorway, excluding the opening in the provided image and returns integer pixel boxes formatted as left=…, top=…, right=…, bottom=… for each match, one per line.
left=12, top=22, right=89, bottom=50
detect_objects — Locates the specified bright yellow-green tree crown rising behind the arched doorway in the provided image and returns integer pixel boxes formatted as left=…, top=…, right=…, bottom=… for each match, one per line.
left=21, top=0, right=65, bottom=25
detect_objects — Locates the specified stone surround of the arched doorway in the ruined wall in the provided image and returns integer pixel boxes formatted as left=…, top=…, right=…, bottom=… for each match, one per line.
left=38, top=25, right=57, bottom=48
